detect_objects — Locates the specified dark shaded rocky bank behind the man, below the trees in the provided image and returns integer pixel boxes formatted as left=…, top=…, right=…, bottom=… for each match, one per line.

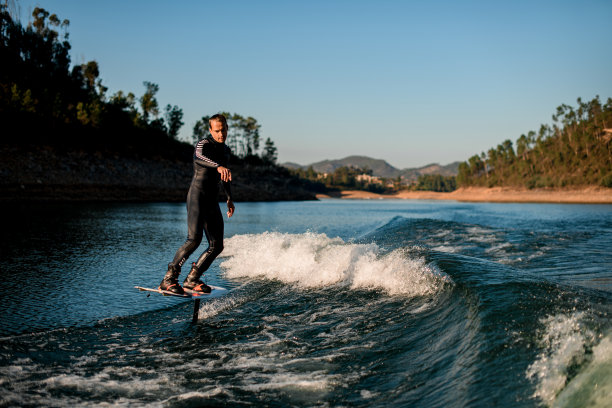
left=0, top=146, right=316, bottom=202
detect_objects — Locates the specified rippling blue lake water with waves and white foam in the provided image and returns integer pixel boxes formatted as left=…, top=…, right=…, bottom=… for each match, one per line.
left=0, top=200, right=612, bottom=408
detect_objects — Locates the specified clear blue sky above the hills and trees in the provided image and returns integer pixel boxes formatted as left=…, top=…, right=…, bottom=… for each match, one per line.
left=10, top=0, right=612, bottom=168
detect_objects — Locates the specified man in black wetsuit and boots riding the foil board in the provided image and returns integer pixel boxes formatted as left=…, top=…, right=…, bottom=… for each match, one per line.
left=159, top=114, right=235, bottom=294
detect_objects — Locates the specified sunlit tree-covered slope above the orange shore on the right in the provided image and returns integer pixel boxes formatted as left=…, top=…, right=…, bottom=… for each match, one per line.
left=457, top=96, right=612, bottom=188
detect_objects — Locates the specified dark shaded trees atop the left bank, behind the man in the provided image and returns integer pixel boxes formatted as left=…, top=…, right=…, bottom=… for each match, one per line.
left=0, top=4, right=277, bottom=163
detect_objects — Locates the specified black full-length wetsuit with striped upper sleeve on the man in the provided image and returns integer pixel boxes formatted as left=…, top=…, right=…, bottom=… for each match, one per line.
left=170, top=137, right=232, bottom=272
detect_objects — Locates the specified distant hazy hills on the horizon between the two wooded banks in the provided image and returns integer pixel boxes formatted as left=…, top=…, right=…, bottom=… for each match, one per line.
left=282, top=156, right=460, bottom=182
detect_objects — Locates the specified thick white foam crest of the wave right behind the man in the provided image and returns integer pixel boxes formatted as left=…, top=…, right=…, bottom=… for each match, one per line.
left=221, top=232, right=450, bottom=296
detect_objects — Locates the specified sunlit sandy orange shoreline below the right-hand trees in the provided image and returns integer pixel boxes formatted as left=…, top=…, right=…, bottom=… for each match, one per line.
left=317, top=187, right=612, bottom=204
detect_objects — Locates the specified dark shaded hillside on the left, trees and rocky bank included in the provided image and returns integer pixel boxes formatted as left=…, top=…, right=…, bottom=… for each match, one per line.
left=0, top=4, right=316, bottom=202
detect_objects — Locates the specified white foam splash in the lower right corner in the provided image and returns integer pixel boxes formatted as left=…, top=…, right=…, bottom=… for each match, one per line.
left=527, top=312, right=595, bottom=406
